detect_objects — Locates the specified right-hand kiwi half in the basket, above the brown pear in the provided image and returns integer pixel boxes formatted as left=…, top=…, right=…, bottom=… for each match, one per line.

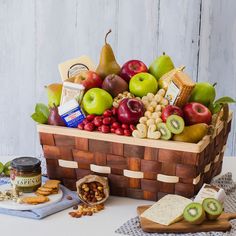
left=166, top=115, right=184, bottom=134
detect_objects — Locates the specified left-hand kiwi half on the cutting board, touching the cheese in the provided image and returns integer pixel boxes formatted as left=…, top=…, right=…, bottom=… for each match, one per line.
left=183, top=202, right=206, bottom=225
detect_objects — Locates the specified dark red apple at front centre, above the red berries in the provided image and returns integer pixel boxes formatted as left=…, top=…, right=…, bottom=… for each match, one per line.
left=117, top=98, right=145, bottom=124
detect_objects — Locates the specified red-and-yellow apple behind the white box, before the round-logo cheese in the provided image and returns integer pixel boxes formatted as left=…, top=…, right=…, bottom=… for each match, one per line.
left=74, top=71, right=103, bottom=91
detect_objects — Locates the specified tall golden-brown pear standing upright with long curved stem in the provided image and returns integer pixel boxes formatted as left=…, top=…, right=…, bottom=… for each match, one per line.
left=96, top=30, right=120, bottom=79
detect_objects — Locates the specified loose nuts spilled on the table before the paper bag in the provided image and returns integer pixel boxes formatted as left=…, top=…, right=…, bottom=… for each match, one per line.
left=69, top=204, right=104, bottom=218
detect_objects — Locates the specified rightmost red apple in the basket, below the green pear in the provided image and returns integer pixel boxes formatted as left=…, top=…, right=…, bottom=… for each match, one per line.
left=183, top=102, right=212, bottom=125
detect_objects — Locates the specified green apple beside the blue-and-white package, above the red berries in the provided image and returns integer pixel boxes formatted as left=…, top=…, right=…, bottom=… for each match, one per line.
left=82, top=88, right=113, bottom=115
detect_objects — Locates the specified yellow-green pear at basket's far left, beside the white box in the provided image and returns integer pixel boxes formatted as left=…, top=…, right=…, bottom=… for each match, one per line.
left=45, top=83, right=62, bottom=107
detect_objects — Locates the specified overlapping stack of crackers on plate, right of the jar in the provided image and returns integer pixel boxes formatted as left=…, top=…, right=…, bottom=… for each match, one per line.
left=36, top=179, right=60, bottom=196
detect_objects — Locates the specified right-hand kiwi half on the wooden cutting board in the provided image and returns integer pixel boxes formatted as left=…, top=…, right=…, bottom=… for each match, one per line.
left=202, top=198, right=223, bottom=220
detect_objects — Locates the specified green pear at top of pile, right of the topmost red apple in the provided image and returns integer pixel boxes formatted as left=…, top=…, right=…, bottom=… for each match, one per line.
left=149, top=52, right=174, bottom=81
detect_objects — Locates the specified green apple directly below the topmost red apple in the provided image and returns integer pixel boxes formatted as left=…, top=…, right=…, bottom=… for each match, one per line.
left=129, top=72, right=158, bottom=97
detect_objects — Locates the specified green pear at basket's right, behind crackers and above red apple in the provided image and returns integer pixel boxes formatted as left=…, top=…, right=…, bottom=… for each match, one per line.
left=189, top=82, right=216, bottom=107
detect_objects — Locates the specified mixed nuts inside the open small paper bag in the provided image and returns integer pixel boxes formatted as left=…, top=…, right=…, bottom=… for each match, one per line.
left=79, top=181, right=105, bottom=203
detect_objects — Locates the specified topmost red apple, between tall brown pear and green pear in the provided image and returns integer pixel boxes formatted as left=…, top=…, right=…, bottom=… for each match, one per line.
left=120, top=60, right=148, bottom=82
